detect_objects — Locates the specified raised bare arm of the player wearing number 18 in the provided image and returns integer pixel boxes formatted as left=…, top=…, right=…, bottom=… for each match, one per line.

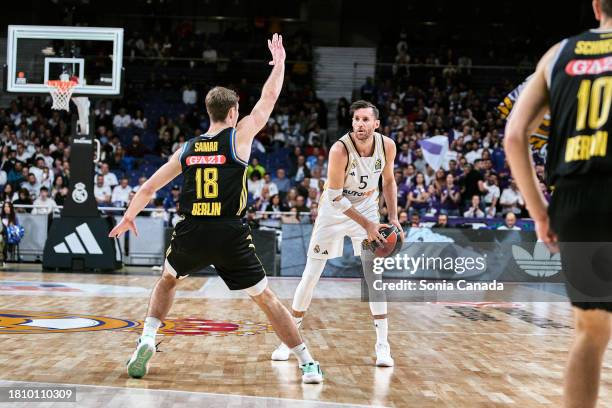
left=236, top=34, right=285, bottom=144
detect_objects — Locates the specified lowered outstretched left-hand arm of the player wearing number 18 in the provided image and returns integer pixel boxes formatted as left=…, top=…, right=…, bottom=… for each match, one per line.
left=108, top=149, right=182, bottom=237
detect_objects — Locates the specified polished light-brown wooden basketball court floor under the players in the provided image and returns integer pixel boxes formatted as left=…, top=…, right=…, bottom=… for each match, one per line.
left=0, top=265, right=612, bottom=407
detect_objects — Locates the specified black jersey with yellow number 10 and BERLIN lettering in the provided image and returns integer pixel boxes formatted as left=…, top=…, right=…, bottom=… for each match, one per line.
left=546, top=30, right=612, bottom=185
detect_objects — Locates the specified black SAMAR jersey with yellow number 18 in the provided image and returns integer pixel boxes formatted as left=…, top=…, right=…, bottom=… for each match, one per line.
left=179, top=127, right=247, bottom=217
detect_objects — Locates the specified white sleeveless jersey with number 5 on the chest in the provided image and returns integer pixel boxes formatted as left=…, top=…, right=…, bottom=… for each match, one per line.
left=322, top=132, right=385, bottom=212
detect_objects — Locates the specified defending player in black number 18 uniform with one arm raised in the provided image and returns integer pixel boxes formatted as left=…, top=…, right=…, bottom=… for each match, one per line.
left=110, top=34, right=323, bottom=383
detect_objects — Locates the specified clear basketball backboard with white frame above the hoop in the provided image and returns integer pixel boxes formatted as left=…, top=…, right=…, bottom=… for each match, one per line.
left=5, top=25, right=123, bottom=96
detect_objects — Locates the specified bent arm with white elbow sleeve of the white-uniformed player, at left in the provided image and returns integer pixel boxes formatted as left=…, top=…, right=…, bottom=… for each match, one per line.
left=324, top=142, right=386, bottom=244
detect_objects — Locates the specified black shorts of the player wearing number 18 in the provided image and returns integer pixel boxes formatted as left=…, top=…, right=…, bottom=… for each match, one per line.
left=166, top=216, right=266, bottom=290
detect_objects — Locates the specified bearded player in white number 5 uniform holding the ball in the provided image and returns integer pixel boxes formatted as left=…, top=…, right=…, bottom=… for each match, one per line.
left=272, top=101, right=403, bottom=367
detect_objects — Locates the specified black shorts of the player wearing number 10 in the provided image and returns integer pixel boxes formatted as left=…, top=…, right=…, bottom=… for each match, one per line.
left=548, top=175, right=612, bottom=312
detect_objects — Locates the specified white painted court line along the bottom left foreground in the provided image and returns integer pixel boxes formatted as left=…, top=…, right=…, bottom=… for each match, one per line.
left=0, top=379, right=385, bottom=408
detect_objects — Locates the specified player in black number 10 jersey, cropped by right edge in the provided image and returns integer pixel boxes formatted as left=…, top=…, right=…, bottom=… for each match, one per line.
left=505, top=0, right=612, bottom=408
